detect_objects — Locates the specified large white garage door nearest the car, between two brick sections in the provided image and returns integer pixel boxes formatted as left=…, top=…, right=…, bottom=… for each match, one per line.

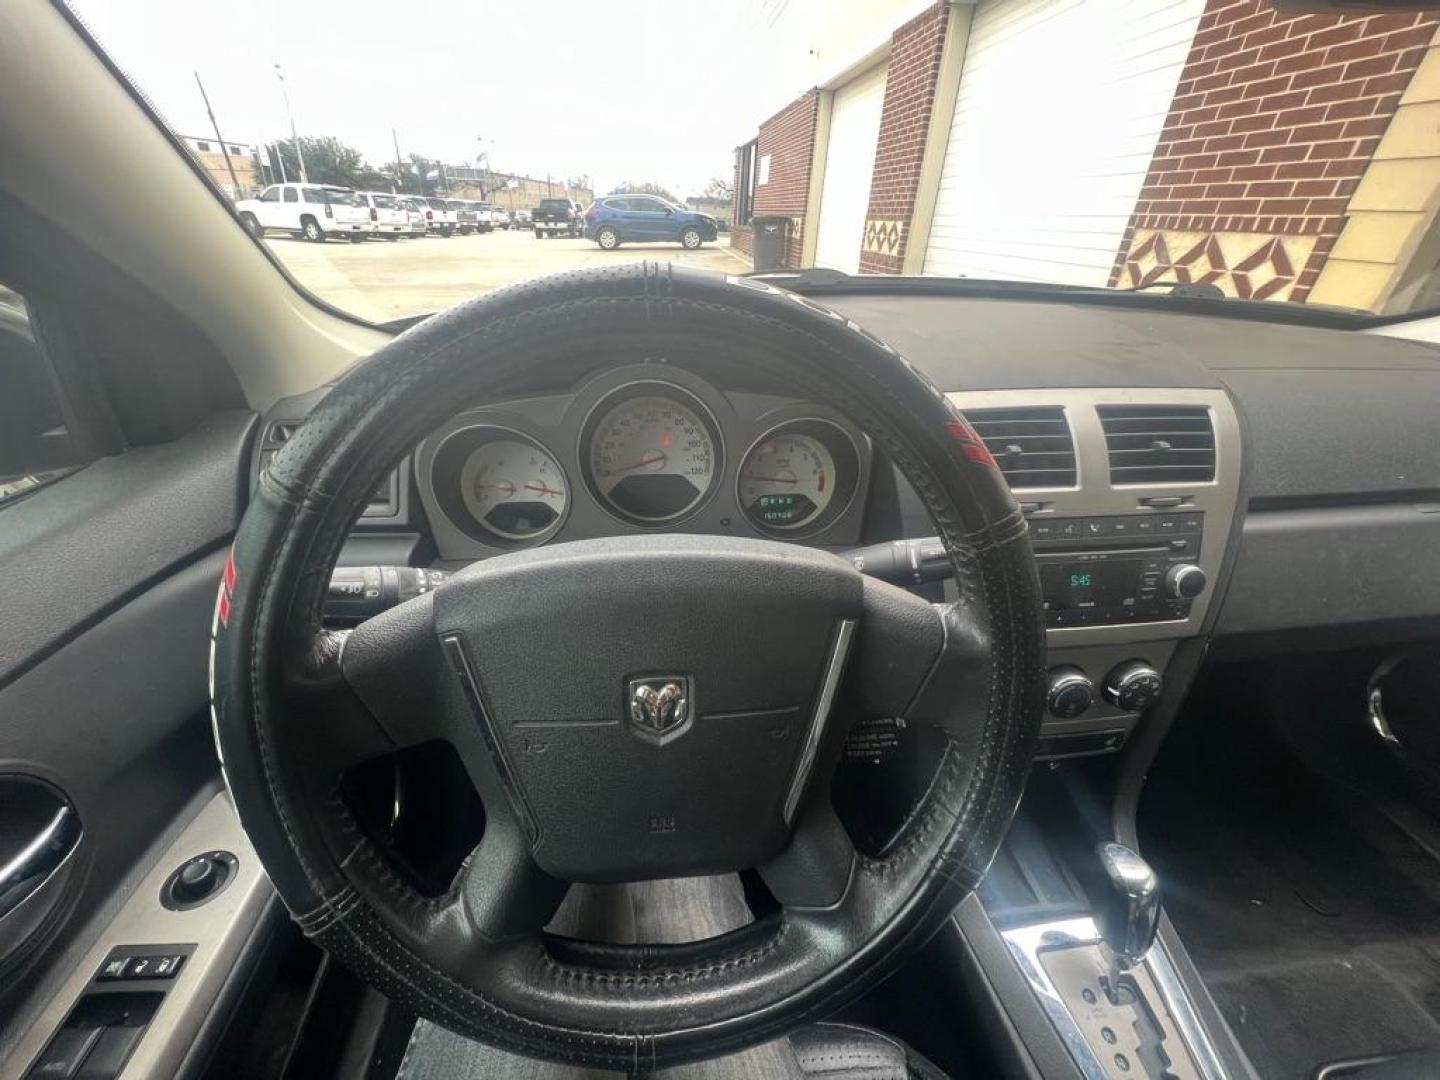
left=924, top=0, right=1204, bottom=285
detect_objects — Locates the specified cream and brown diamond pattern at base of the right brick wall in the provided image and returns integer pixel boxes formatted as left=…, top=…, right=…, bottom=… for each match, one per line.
left=1119, top=229, right=1316, bottom=300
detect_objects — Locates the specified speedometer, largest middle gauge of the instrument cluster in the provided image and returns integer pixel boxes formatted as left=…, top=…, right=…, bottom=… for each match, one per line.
left=586, top=383, right=720, bottom=524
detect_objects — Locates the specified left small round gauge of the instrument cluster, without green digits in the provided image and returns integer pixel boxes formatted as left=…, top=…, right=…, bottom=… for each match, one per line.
left=459, top=439, right=566, bottom=540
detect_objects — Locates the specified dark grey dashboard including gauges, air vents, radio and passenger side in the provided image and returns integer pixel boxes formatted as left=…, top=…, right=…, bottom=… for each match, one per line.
left=253, top=288, right=1440, bottom=757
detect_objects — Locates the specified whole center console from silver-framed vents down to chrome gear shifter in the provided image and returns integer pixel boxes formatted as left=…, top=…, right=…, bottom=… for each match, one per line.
left=944, top=389, right=1244, bottom=1080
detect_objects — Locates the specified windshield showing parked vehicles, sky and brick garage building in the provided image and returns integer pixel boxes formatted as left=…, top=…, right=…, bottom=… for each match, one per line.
left=73, top=0, right=1440, bottom=321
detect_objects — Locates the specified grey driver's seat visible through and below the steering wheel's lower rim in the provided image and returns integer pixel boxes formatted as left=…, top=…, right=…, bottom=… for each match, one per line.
left=396, top=874, right=946, bottom=1080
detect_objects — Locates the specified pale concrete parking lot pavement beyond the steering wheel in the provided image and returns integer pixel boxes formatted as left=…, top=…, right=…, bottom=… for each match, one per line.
left=265, top=230, right=750, bottom=323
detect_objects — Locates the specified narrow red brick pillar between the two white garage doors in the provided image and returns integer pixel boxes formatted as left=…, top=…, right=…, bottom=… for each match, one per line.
left=860, top=3, right=949, bottom=274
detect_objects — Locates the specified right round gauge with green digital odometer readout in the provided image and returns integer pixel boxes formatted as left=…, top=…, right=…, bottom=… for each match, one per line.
left=736, top=419, right=858, bottom=533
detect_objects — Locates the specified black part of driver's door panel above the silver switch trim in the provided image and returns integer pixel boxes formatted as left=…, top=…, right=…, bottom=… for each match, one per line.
left=0, top=413, right=253, bottom=1042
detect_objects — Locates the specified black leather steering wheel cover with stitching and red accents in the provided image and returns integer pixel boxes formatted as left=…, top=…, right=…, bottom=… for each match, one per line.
left=212, top=264, right=1044, bottom=1070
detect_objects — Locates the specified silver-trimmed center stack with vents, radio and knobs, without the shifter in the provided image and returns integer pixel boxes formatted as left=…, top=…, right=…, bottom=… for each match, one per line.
left=944, top=387, right=1240, bottom=759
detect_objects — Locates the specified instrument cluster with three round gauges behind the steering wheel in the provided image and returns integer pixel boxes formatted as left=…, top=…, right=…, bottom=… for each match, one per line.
left=416, top=367, right=870, bottom=554
